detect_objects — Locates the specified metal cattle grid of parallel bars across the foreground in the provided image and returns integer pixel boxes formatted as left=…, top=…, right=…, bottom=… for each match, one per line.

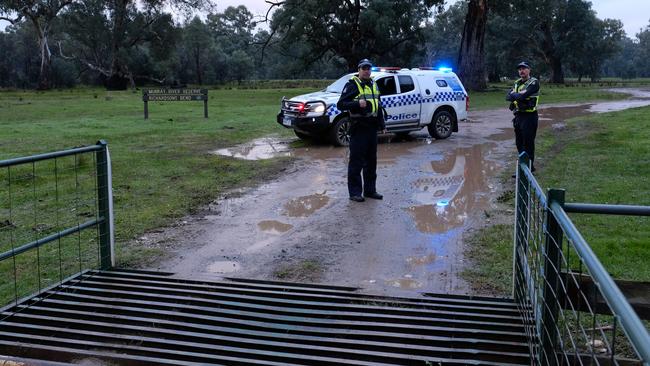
left=0, top=270, right=530, bottom=365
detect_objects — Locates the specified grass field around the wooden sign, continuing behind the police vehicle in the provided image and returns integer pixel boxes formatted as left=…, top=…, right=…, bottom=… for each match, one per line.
left=0, top=81, right=640, bottom=274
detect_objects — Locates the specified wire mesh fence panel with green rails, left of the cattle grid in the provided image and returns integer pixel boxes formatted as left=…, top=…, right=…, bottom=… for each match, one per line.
left=0, top=144, right=110, bottom=314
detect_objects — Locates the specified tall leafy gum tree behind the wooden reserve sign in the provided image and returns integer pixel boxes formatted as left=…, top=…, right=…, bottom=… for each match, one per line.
left=60, top=0, right=213, bottom=90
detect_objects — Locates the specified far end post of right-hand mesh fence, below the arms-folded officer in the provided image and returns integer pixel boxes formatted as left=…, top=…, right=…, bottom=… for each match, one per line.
left=512, top=152, right=530, bottom=301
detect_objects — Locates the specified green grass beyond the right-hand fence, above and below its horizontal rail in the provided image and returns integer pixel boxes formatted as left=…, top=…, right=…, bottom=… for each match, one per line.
left=539, top=108, right=650, bottom=281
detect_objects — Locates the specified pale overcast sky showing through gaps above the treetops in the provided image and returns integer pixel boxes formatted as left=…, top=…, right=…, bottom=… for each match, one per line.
left=0, top=0, right=650, bottom=38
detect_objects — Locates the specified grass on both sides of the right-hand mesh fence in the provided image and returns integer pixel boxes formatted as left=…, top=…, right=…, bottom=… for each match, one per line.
left=466, top=107, right=650, bottom=294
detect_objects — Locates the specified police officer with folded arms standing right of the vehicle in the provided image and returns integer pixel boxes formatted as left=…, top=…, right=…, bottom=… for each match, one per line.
left=506, top=62, right=539, bottom=172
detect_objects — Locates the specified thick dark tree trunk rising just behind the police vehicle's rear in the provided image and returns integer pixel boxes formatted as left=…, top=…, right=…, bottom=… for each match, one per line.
left=458, top=0, right=488, bottom=90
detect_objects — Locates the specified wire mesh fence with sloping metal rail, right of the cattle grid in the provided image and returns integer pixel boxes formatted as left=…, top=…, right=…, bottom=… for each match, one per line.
left=513, top=156, right=650, bottom=365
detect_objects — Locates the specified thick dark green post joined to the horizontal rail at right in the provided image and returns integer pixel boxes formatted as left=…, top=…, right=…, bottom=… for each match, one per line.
left=537, top=189, right=565, bottom=365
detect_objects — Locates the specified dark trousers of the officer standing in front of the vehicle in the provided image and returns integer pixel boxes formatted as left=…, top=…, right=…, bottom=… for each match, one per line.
left=348, top=124, right=377, bottom=197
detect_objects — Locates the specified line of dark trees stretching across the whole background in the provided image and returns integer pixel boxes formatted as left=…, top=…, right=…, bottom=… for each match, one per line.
left=0, top=0, right=650, bottom=89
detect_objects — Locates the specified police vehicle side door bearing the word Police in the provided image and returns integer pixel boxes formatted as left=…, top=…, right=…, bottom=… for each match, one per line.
left=382, top=75, right=422, bottom=130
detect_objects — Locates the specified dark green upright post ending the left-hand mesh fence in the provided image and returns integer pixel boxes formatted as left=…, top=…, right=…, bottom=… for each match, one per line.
left=97, top=140, right=115, bottom=269
